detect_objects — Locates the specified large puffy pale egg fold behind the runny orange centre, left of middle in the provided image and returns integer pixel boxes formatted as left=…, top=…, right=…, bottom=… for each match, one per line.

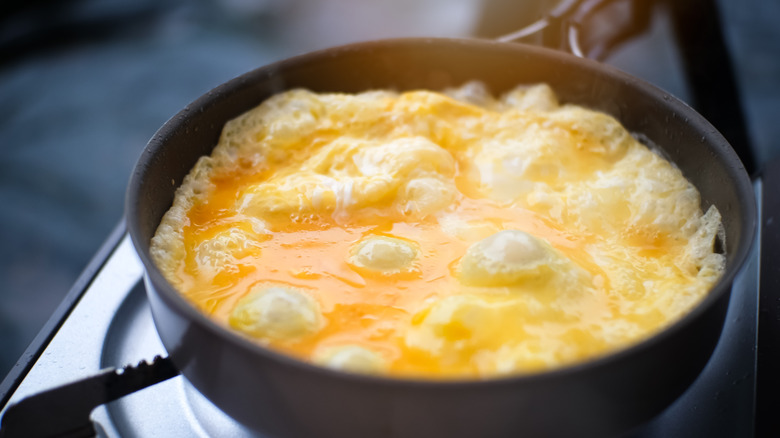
left=236, top=137, right=457, bottom=221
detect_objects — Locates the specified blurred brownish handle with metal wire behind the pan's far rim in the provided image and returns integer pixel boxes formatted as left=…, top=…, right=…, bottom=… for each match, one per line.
left=496, top=0, right=653, bottom=61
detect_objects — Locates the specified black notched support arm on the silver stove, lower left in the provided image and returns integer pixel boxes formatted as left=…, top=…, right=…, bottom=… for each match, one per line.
left=0, top=356, right=179, bottom=438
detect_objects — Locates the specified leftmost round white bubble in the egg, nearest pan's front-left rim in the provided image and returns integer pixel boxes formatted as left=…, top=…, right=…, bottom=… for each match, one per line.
left=229, top=287, right=322, bottom=339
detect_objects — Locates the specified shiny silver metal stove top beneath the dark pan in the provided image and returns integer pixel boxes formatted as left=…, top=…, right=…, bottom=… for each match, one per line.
left=0, top=182, right=761, bottom=438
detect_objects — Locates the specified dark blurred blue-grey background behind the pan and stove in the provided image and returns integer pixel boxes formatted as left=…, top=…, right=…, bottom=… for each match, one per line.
left=0, top=0, right=780, bottom=379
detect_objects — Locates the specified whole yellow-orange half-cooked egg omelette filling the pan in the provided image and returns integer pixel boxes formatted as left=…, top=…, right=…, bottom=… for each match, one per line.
left=151, top=82, right=725, bottom=378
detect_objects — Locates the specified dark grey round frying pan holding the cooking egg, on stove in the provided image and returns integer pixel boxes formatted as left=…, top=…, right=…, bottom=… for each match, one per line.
left=126, top=38, right=756, bottom=438
